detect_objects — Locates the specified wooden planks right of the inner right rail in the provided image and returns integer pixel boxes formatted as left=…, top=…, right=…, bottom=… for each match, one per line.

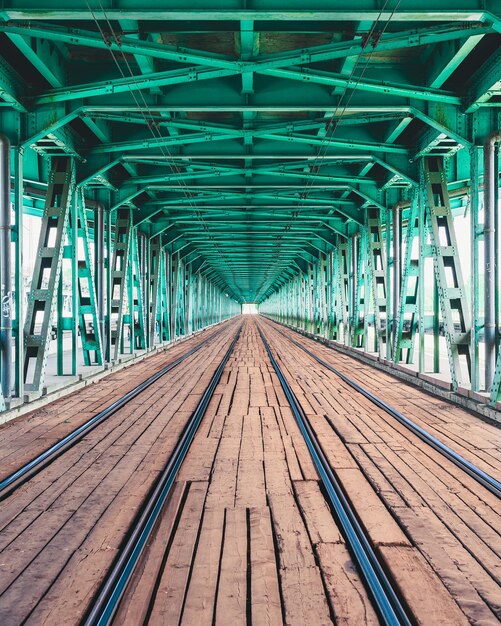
left=260, top=318, right=501, bottom=624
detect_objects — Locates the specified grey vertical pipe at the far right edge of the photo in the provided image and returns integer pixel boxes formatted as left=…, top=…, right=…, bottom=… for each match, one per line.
left=484, top=131, right=501, bottom=391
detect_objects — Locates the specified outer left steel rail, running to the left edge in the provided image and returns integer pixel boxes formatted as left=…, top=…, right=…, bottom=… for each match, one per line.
left=0, top=328, right=230, bottom=501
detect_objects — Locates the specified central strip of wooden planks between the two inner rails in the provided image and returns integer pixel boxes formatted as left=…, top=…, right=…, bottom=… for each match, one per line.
left=110, top=321, right=379, bottom=626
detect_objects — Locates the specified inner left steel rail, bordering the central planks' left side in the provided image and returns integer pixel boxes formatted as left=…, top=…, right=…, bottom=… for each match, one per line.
left=82, top=325, right=243, bottom=626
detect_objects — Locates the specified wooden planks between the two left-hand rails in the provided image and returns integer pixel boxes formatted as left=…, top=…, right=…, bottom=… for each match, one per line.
left=0, top=322, right=238, bottom=626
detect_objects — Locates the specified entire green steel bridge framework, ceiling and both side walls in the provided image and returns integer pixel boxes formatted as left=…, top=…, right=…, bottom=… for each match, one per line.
left=0, top=0, right=501, bottom=410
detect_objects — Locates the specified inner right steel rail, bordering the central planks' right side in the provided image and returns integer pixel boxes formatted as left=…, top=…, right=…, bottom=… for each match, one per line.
left=257, top=324, right=413, bottom=626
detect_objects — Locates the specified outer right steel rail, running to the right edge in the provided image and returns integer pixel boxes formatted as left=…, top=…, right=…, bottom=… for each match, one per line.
left=266, top=318, right=501, bottom=498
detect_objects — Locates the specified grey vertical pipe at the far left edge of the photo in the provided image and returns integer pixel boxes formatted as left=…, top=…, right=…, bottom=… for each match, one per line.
left=0, top=135, right=12, bottom=398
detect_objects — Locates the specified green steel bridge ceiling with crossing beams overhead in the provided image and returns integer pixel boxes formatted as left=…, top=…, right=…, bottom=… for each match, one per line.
left=0, top=0, right=501, bottom=302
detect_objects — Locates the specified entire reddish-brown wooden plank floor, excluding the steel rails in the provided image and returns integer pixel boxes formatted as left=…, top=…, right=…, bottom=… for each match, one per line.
left=0, top=318, right=501, bottom=626
